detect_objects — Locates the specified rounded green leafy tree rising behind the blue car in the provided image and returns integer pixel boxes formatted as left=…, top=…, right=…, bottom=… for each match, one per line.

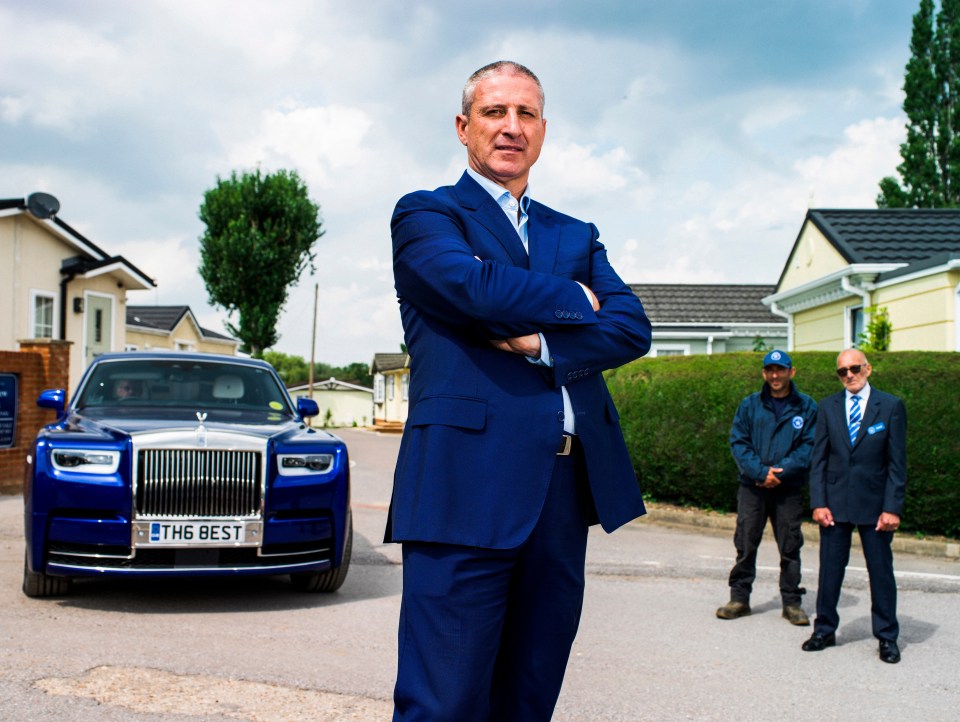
left=200, top=169, right=323, bottom=358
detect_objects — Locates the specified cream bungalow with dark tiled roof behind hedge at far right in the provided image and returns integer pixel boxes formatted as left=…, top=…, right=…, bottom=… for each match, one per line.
left=763, top=208, right=960, bottom=351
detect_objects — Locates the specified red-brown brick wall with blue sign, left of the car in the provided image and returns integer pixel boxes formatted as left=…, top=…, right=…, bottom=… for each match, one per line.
left=0, top=339, right=70, bottom=494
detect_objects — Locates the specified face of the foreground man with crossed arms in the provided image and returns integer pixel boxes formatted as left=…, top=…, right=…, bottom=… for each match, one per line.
left=456, top=72, right=547, bottom=198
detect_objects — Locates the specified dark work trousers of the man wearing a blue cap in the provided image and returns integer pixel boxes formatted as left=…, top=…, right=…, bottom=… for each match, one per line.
left=730, top=484, right=805, bottom=606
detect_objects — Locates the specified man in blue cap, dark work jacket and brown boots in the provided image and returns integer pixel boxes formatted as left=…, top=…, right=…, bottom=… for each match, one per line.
left=717, top=351, right=817, bottom=626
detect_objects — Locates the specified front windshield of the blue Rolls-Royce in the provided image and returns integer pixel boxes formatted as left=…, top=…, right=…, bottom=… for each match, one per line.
left=75, top=358, right=295, bottom=420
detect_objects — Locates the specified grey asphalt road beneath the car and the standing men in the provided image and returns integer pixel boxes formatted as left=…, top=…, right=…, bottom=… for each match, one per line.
left=0, top=429, right=960, bottom=722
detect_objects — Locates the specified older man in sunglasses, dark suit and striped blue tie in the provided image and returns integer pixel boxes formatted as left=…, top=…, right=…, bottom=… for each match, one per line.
left=803, top=349, right=907, bottom=664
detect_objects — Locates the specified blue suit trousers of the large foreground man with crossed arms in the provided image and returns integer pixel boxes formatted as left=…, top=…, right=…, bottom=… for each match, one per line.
left=393, top=444, right=592, bottom=722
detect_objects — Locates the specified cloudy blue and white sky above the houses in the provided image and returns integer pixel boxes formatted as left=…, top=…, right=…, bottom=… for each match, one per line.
left=0, top=0, right=919, bottom=365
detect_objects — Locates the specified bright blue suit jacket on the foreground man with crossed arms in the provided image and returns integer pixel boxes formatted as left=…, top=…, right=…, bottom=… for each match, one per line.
left=386, top=173, right=650, bottom=549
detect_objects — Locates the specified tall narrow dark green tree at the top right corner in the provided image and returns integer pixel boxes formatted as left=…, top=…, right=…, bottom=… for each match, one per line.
left=877, top=0, right=960, bottom=208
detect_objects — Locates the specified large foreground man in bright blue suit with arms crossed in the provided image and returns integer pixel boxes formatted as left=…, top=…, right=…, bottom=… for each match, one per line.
left=386, top=61, right=650, bottom=722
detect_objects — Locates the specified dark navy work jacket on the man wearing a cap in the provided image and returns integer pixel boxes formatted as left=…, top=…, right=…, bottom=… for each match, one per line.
left=730, top=381, right=817, bottom=487
